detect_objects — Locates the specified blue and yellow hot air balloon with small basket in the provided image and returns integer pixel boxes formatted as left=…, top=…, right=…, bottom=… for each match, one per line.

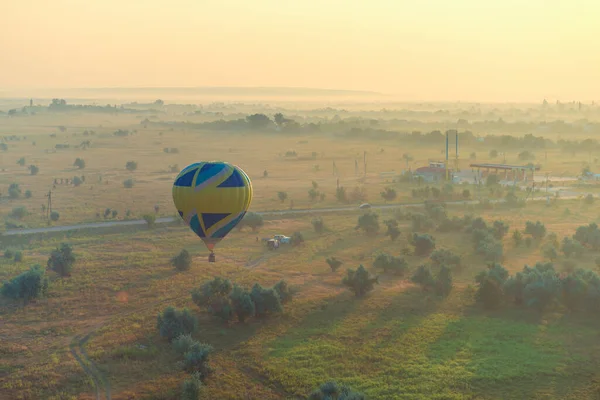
left=173, top=161, right=252, bottom=262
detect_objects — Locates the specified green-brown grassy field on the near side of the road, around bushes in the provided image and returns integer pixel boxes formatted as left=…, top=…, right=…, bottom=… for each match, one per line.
left=0, top=203, right=600, bottom=399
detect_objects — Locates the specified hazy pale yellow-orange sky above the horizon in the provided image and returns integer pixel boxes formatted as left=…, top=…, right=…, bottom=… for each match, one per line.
left=0, top=0, right=600, bottom=101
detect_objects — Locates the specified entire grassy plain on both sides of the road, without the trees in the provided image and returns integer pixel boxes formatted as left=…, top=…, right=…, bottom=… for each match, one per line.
left=0, top=101, right=600, bottom=400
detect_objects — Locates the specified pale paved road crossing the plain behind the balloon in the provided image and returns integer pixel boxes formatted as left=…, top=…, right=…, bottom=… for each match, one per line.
left=2, top=196, right=578, bottom=236
